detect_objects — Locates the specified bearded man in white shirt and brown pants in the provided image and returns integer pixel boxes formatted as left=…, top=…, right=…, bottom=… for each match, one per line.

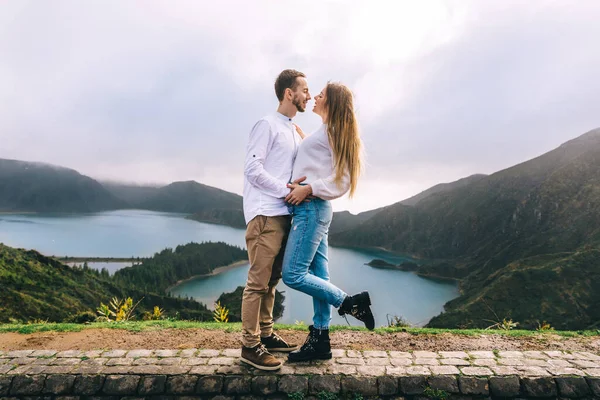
left=241, top=69, right=310, bottom=371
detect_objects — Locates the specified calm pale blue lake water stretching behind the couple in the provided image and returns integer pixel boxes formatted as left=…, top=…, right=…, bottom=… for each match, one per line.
left=0, top=210, right=458, bottom=326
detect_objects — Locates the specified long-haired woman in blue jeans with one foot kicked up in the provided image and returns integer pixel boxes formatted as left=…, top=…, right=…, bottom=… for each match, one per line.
left=283, top=83, right=375, bottom=361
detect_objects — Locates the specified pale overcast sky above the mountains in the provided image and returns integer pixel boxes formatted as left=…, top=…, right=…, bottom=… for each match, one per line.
left=0, top=0, right=600, bottom=212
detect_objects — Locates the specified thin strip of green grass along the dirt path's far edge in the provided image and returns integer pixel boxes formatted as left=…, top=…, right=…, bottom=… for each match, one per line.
left=0, top=320, right=600, bottom=337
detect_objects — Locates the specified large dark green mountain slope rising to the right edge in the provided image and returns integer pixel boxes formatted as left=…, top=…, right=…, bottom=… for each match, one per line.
left=330, top=129, right=600, bottom=329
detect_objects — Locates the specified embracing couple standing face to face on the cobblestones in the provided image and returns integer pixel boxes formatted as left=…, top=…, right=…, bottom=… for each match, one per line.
left=241, top=69, right=375, bottom=371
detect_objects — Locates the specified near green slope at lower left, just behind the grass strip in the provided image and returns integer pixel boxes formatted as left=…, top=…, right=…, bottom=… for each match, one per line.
left=0, top=244, right=212, bottom=322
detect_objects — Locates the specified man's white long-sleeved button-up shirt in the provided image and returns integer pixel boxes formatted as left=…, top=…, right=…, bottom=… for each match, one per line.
left=244, top=112, right=301, bottom=224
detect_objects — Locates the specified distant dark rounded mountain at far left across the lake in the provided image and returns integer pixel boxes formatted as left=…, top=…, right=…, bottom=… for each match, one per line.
left=0, top=159, right=125, bottom=212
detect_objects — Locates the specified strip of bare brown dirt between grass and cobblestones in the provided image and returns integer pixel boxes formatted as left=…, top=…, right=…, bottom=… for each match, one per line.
left=0, top=329, right=600, bottom=352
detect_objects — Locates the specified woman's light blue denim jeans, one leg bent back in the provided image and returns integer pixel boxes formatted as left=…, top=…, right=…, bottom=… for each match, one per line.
left=282, top=198, right=347, bottom=329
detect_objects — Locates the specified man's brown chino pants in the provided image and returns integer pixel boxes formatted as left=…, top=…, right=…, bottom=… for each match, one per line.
left=242, top=215, right=291, bottom=347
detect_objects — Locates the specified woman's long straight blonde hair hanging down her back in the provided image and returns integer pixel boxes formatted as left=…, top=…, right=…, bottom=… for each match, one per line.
left=325, top=82, right=362, bottom=197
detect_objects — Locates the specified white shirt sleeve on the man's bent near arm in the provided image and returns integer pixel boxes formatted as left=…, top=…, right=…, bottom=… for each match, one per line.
left=244, top=119, right=290, bottom=198
